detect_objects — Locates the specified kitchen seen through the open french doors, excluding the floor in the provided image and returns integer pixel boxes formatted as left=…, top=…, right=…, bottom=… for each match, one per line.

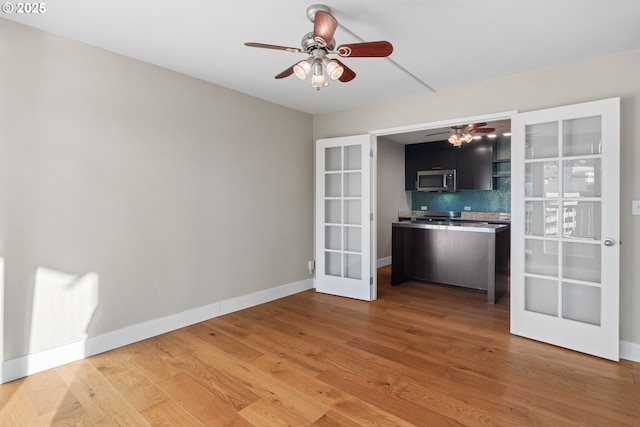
left=377, top=120, right=511, bottom=304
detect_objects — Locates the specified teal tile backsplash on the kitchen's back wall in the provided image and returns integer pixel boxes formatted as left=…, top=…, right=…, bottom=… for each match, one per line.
left=411, top=178, right=511, bottom=212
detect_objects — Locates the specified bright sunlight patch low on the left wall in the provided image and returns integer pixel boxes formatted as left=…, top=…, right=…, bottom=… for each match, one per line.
left=29, top=267, right=99, bottom=353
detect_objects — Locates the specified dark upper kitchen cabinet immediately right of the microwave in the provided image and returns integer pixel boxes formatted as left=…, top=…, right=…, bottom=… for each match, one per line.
left=457, top=138, right=493, bottom=190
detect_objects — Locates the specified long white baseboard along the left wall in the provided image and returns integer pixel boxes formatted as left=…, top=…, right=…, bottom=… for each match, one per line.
left=0, top=279, right=313, bottom=384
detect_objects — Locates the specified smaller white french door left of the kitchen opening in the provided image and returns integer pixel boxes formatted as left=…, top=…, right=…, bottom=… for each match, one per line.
left=315, top=135, right=377, bottom=301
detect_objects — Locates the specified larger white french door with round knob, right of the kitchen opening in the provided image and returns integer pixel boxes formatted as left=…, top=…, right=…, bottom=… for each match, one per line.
left=511, top=98, right=620, bottom=360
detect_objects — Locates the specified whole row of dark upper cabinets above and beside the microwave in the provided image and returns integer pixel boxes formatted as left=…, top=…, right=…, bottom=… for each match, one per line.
left=405, top=138, right=494, bottom=191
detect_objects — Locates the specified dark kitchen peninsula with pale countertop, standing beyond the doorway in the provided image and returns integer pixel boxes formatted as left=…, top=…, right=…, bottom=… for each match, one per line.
left=391, top=219, right=510, bottom=304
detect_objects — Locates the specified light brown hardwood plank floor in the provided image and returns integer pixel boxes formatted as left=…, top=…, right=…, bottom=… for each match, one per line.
left=0, top=267, right=640, bottom=427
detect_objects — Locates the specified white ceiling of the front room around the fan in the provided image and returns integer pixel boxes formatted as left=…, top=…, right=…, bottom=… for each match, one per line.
left=2, top=0, right=640, bottom=114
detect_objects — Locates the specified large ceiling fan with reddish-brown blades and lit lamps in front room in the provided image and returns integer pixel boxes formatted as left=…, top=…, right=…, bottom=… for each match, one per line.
left=245, top=4, right=393, bottom=90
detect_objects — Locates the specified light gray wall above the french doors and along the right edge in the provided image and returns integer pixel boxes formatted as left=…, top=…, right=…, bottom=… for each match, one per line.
left=315, top=51, right=640, bottom=344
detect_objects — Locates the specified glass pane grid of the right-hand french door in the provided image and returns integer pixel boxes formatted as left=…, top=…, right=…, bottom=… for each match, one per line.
left=525, top=116, right=602, bottom=325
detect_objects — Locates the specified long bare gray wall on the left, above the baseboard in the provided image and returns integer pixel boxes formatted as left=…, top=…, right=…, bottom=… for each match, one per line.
left=0, top=19, right=313, bottom=360
